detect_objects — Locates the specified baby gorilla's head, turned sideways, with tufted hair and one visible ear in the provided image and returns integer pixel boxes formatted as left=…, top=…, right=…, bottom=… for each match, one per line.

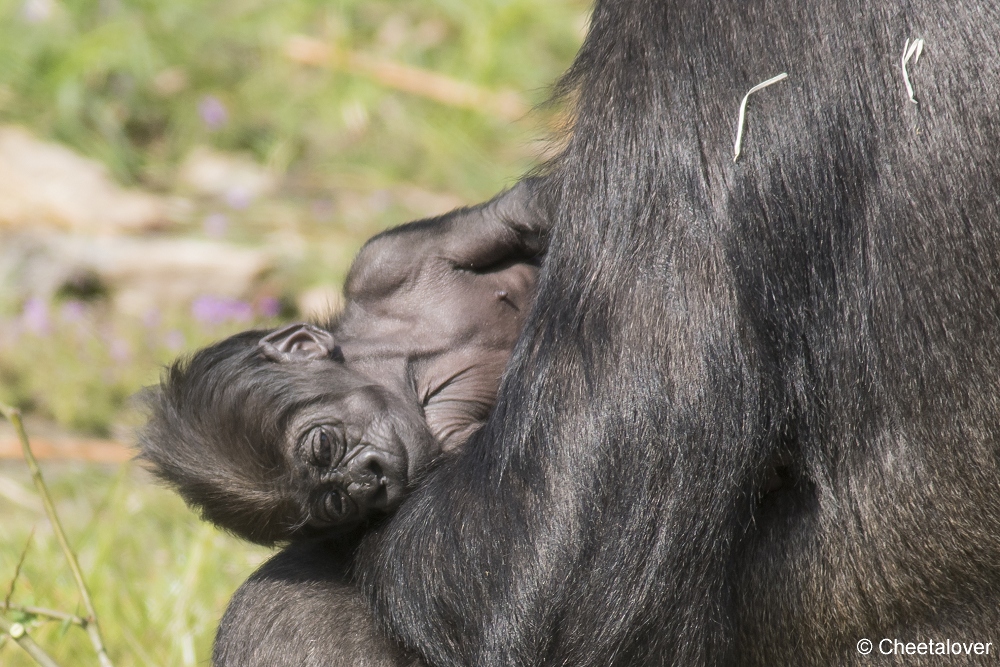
left=139, top=324, right=439, bottom=544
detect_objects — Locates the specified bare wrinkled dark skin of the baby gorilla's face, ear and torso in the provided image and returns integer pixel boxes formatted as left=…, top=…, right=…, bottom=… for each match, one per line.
left=262, top=183, right=540, bottom=526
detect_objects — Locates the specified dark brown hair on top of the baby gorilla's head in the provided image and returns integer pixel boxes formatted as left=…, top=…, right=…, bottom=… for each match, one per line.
left=140, top=331, right=304, bottom=544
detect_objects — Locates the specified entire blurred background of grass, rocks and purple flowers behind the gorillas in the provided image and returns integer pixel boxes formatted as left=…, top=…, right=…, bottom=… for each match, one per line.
left=0, top=0, right=589, bottom=665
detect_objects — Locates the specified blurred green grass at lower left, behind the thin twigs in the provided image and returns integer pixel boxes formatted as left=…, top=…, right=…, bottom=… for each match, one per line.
left=0, top=463, right=268, bottom=667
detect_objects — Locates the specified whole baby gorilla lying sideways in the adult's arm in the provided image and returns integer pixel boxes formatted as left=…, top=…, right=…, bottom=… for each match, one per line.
left=139, top=179, right=548, bottom=544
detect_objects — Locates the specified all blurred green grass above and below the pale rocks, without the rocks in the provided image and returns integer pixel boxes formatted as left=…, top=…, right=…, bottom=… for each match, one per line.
left=0, top=0, right=588, bottom=666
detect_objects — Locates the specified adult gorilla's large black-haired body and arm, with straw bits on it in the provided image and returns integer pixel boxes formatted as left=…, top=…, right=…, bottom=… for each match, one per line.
left=217, top=0, right=1000, bottom=667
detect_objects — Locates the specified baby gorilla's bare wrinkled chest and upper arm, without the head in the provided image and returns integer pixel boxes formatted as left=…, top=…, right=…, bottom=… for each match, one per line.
left=337, top=179, right=550, bottom=450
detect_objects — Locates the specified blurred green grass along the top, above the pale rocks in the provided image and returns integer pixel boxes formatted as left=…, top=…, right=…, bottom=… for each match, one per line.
left=0, top=0, right=585, bottom=199
